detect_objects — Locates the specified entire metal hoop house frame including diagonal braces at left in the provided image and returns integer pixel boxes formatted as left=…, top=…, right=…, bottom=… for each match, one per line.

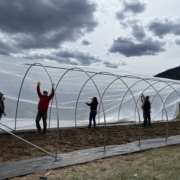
left=0, top=63, right=180, bottom=161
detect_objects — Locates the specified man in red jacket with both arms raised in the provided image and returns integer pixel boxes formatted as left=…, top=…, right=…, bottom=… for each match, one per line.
left=36, top=82, right=55, bottom=135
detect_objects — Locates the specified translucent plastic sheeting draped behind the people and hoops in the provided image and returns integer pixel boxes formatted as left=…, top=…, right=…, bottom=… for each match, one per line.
left=0, top=60, right=180, bottom=129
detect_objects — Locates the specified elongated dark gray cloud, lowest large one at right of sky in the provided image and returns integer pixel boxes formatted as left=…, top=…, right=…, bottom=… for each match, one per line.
left=109, top=37, right=165, bottom=57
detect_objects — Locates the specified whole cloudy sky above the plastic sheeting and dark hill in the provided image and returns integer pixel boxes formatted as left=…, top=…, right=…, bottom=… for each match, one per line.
left=0, top=0, right=180, bottom=76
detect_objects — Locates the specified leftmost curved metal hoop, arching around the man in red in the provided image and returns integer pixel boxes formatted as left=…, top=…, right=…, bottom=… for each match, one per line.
left=15, top=63, right=59, bottom=161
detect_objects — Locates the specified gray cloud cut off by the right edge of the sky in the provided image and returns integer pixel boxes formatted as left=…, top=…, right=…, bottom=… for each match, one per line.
left=148, top=19, right=180, bottom=38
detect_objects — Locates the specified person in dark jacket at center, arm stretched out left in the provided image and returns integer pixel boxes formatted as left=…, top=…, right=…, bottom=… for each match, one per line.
left=86, top=97, right=98, bottom=129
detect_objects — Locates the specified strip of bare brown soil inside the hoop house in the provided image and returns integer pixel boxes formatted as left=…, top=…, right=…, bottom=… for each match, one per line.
left=0, top=121, right=180, bottom=163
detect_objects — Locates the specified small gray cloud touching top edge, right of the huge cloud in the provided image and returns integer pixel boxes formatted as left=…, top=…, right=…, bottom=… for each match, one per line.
left=116, top=0, right=146, bottom=20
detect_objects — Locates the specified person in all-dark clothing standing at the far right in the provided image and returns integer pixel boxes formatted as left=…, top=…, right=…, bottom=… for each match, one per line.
left=143, top=96, right=151, bottom=126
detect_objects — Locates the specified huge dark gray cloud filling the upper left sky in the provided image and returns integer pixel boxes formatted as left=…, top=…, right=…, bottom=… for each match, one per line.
left=0, top=0, right=97, bottom=50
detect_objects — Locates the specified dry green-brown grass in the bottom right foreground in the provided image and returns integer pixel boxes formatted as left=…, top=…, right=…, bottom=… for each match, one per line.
left=11, top=145, right=180, bottom=180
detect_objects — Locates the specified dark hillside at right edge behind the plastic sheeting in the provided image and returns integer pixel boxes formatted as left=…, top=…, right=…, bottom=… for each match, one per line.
left=154, top=66, right=180, bottom=80
